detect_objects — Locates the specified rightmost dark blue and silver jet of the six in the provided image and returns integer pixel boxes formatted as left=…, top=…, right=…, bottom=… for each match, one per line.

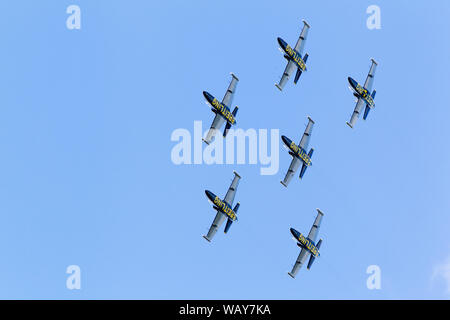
left=347, top=59, right=378, bottom=128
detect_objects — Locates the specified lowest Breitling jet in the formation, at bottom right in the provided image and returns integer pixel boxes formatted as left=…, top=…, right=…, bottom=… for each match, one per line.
left=288, top=209, right=323, bottom=278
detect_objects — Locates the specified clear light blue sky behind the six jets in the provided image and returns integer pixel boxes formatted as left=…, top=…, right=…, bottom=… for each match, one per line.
left=0, top=0, right=450, bottom=299
